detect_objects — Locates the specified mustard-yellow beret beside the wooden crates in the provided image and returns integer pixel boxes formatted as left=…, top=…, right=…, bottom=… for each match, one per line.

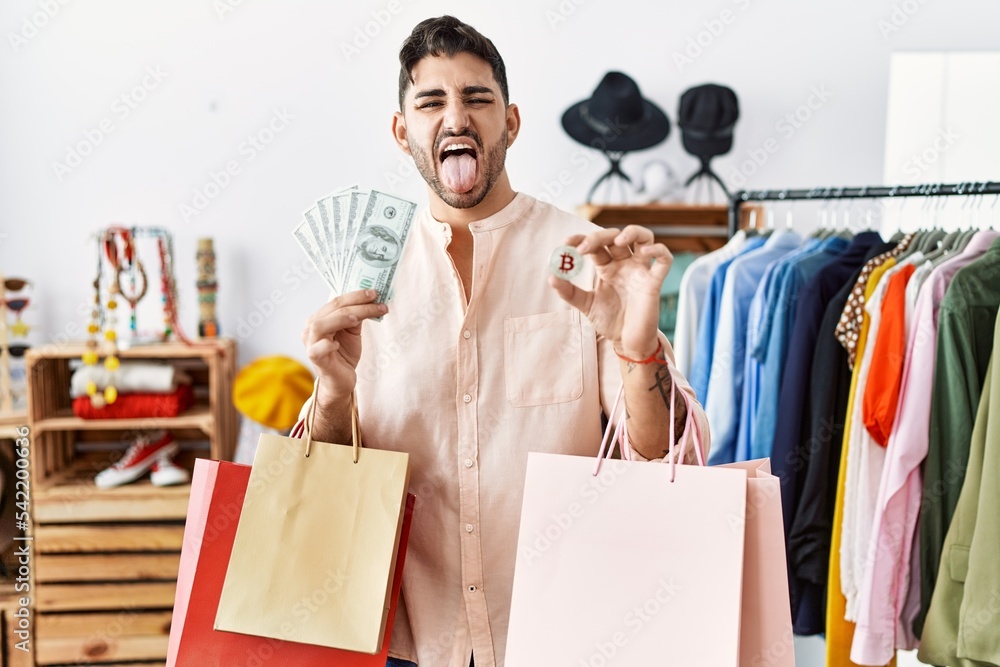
left=233, top=356, right=313, bottom=431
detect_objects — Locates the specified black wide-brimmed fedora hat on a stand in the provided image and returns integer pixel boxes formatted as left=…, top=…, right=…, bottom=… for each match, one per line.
left=562, top=72, right=670, bottom=153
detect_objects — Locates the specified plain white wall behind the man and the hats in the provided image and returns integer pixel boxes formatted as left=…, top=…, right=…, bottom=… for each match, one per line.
left=0, top=0, right=1000, bottom=666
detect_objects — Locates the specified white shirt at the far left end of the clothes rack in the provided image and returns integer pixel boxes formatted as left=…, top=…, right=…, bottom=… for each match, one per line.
left=673, top=229, right=747, bottom=375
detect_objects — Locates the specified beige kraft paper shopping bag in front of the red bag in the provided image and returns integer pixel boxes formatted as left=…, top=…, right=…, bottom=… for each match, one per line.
left=215, top=394, right=409, bottom=654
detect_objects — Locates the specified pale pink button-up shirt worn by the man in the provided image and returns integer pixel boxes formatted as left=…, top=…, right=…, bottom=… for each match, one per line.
left=292, top=194, right=708, bottom=667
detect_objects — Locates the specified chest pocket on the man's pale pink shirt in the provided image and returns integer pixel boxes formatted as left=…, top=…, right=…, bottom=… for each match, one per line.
left=504, top=310, right=583, bottom=407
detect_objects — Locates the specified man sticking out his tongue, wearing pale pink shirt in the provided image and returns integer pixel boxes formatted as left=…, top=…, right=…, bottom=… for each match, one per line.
left=303, top=16, right=708, bottom=667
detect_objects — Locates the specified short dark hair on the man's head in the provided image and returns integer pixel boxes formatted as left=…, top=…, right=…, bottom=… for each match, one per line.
left=399, top=16, right=510, bottom=111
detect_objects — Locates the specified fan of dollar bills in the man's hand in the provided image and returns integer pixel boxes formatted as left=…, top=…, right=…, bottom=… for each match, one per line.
left=292, top=186, right=417, bottom=303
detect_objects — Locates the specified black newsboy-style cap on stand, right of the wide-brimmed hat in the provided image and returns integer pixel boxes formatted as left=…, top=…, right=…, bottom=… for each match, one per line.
left=677, top=83, right=740, bottom=157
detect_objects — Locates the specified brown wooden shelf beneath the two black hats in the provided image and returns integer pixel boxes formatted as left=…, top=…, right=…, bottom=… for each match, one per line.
left=577, top=204, right=762, bottom=253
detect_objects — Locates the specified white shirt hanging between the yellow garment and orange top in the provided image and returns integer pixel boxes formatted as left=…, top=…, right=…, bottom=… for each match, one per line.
left=840, top=257, right=896, bottom=621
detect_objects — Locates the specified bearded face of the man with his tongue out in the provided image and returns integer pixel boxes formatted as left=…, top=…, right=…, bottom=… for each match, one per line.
left=396, top=53, right=516, bottom=208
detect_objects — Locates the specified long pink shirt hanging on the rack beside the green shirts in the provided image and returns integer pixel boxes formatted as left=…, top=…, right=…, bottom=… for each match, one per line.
left=851, top=231, right=1000, bottom=665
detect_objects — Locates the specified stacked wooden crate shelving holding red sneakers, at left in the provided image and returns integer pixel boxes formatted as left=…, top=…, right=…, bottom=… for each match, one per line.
left=26, top=340, right=238, bottom=667
